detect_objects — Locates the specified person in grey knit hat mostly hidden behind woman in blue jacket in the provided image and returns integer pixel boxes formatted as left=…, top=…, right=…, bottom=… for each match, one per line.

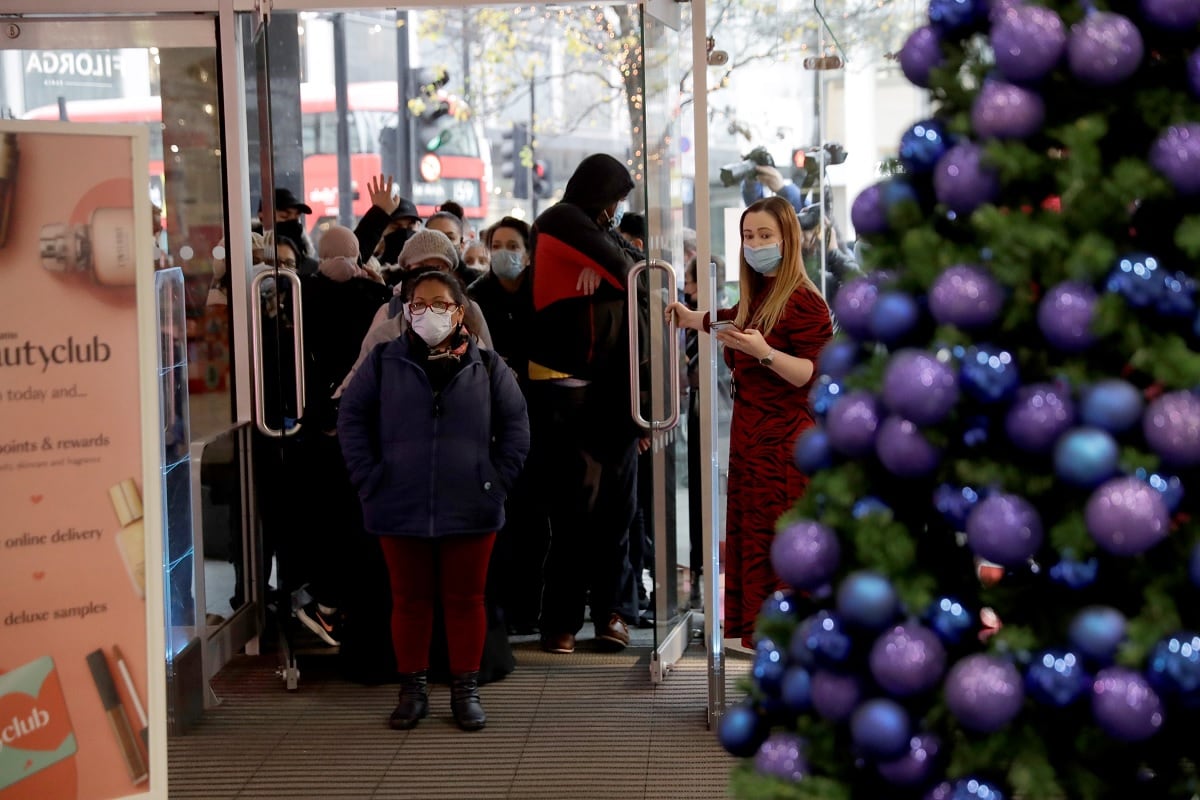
left=335, top=229, right=493, bottom=397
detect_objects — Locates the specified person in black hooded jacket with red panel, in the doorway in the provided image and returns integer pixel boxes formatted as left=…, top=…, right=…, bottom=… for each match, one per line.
left=527, top=154, right=638, bottom=652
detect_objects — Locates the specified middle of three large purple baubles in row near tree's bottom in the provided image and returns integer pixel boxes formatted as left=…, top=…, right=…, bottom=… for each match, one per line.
left=946, top=654, right=1025, bottom=733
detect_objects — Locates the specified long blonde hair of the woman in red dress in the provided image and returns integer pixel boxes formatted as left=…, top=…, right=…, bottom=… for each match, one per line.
left=733, top=197, right=821, bottom=336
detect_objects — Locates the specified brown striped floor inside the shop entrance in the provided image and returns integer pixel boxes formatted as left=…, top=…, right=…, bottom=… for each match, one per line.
left=169, top=640, right=749, bottom=800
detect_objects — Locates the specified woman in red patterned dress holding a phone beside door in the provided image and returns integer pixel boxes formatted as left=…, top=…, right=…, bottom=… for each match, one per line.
left=667, top=197, right=833, bottom=646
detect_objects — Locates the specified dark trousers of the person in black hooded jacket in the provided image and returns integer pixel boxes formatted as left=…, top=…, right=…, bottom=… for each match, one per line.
left=526, top=381, right=637, bottom=636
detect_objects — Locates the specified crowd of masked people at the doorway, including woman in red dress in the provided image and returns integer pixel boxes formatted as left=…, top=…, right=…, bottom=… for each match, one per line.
left=246, top=155, right=832, bottom=730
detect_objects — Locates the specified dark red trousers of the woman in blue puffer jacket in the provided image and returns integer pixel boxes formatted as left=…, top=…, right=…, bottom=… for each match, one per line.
left=379, top=533, right=496, bottom=675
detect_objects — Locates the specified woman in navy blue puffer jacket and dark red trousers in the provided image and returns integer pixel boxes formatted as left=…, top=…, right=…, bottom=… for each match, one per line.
left=337, top=272, right=529, bottom=730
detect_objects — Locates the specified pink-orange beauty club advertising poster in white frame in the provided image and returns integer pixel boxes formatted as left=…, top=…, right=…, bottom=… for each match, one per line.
left=0, top=122, right=166, bottom=800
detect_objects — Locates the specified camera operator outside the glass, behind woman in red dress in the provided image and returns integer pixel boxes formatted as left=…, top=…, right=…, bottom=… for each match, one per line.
left=742, top=164, right=862, bottom=302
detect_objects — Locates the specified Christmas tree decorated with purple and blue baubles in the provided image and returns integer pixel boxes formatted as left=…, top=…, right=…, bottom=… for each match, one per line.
left=719, top=0, right=1200, bottom=800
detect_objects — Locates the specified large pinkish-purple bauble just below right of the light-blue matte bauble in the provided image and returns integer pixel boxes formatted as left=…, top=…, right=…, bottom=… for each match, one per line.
left=1084, top=476, right=1171, bottom=555
